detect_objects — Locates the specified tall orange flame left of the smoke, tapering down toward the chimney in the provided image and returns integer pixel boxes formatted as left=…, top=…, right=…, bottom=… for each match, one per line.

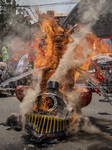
left=35, top=16, right=70, bottom=90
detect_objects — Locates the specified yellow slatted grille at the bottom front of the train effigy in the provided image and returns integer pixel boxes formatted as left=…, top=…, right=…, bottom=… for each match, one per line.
left=25, top=114, right=65, bottom=134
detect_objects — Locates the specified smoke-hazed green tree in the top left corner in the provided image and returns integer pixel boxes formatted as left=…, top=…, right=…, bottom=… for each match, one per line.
left=0, top=0, right=31, bottom=40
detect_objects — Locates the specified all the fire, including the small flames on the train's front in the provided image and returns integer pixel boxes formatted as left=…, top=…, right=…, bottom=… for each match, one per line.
left=32, top=11, right=111, bottom=110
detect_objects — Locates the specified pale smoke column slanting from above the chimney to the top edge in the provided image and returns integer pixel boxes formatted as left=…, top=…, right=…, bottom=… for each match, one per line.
left=51, top=0, right=106, bottom=82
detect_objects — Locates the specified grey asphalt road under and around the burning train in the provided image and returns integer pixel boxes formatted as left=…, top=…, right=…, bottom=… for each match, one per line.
left=0, top=93, right=112, bottom=150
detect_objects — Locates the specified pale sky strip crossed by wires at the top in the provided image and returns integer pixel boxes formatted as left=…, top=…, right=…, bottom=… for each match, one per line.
left=16, top=0, right=79, bottom=21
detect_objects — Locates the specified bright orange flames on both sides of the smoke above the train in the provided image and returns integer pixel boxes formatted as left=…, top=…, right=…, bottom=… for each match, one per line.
left=34, top=11, right=111, bottom=99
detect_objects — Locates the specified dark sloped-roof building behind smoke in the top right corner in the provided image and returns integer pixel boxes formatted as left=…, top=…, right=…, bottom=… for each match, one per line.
left=62, top=0, right=112, bottom=37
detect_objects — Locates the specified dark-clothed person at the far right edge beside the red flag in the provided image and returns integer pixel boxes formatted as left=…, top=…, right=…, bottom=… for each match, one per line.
left=104, top=65, right=112, bottom=92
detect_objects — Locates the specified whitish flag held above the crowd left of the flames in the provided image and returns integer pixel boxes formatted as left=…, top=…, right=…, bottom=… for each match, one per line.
left=15, top=53, right=29, bottom=75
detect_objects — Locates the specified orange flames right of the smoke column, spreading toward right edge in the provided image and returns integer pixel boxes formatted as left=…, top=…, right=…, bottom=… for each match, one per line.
left=75, top=33, right=112, bottom=82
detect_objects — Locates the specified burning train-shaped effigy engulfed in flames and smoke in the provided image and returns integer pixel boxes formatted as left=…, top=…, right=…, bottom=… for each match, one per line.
left=13, top=11, right=110, bottom=142
